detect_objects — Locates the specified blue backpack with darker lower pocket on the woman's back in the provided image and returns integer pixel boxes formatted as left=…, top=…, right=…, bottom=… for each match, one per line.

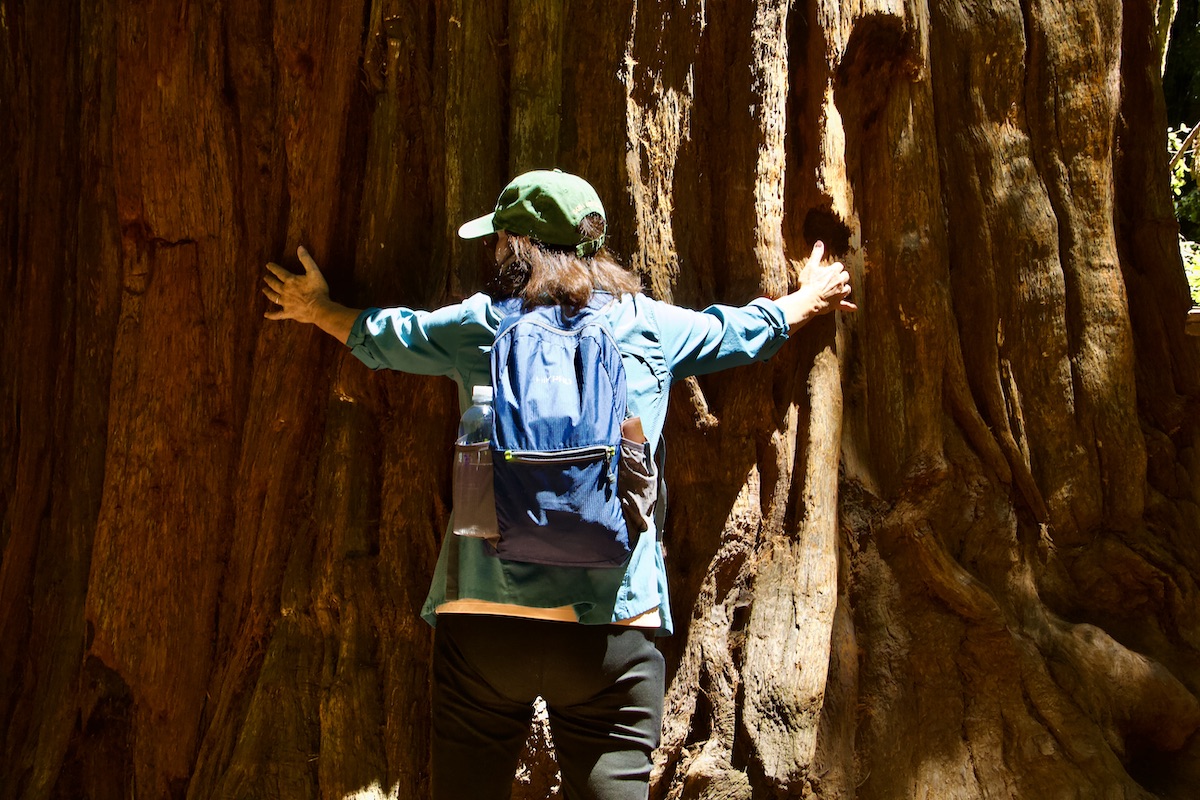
left=488, top=296, right=631, bottom=567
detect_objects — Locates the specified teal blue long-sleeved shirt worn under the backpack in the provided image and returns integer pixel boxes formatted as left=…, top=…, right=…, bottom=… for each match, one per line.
left=347, top=294, right=787, bottom=633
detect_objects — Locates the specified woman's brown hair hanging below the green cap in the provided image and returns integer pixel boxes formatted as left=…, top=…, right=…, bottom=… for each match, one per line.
left=497, top=213, right=642, bottom=313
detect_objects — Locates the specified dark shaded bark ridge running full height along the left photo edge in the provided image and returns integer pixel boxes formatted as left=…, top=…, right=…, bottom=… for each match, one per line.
left=0, top=3, right=94, bottom=792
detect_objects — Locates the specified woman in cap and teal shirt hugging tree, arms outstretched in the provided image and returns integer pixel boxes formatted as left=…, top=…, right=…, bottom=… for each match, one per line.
left=263, top=170, right=854, bottom=799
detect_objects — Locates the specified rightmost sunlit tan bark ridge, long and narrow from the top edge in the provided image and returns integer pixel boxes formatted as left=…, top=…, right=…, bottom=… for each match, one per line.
left=1028, top=2, right=1145, bottom=531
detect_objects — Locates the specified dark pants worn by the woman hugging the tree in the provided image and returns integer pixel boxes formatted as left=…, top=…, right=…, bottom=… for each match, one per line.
left=433, top=614, right=665, bottom=800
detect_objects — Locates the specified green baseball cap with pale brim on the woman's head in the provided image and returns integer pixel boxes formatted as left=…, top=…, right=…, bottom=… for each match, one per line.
left=458, top=169, right=607, bottom=255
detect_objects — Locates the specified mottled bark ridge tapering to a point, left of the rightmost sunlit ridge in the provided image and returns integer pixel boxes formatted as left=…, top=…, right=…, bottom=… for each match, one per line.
left=932, top=4, right=1074, bottom=519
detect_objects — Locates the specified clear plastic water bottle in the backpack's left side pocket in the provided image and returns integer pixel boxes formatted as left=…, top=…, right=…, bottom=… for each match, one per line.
left=454, top=386, right=499, bottom=542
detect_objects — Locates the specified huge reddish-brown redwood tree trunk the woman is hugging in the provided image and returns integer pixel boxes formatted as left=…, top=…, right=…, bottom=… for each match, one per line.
left=0, top=0, right=1200, bottom=800
